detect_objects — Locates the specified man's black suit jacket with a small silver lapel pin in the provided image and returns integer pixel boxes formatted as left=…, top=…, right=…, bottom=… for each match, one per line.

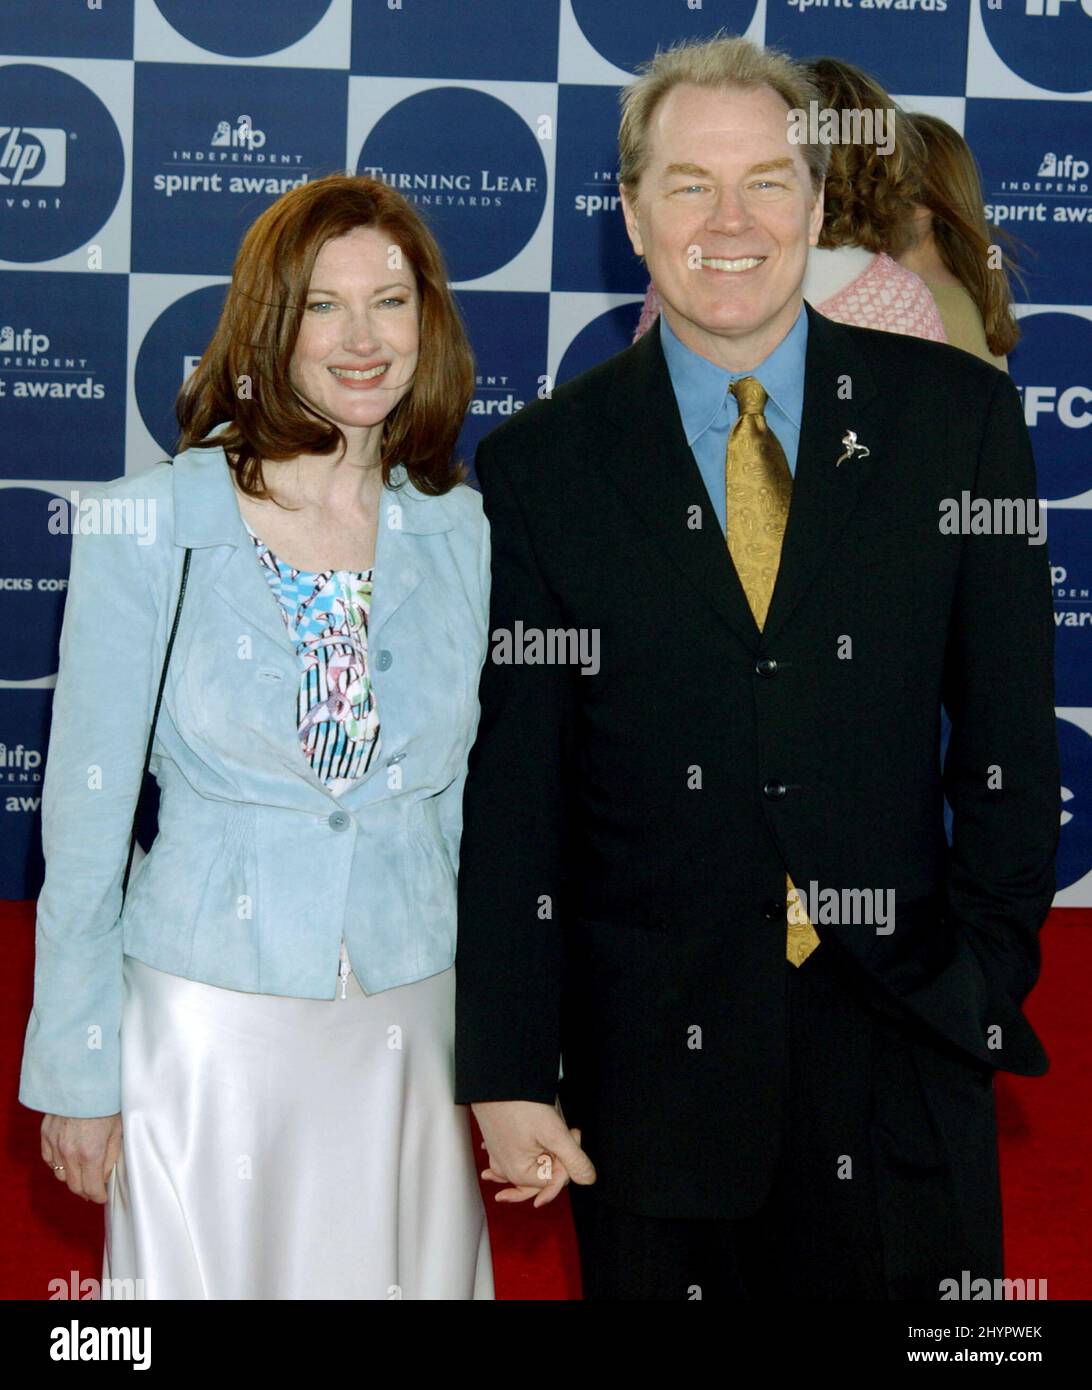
left=456, top=304, right=1059, bottom=1216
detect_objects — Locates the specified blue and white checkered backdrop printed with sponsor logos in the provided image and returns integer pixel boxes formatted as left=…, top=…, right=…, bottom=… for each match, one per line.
left=0, top=0, right=1092, bottom=906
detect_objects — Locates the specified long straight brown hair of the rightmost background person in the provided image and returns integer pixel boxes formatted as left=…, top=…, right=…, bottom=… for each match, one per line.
left=896, top=113, right=1020, bottom=371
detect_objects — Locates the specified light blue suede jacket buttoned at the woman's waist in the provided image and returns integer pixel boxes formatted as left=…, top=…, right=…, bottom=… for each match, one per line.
left=19, top=433, right=489, bottom=1116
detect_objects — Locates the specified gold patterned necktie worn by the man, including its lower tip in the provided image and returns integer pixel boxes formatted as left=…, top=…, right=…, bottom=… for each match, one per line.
left=724, top=377, right=820, bottom=966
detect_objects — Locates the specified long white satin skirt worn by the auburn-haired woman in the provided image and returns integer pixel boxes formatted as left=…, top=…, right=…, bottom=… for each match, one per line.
left=103, top=956, right=493, bottom=1300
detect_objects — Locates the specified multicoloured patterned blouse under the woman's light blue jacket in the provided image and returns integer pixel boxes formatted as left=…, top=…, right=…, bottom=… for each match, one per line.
left=243, top=518, right=381, bottom=998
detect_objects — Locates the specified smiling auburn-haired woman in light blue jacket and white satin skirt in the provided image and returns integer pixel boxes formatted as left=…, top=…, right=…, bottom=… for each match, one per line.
left=19, top=175, right=493, bottom=1300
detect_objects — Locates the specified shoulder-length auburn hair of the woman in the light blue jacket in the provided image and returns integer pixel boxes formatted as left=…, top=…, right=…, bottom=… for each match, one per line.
left=175, top=174, right=475, bottom=498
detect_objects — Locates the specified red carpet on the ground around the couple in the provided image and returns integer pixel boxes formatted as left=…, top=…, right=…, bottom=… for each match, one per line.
left=0, top=902, right=1092, bottom=1300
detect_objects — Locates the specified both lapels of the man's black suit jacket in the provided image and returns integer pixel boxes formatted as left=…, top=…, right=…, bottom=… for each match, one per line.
left=600, top=303, right=879, bottom=652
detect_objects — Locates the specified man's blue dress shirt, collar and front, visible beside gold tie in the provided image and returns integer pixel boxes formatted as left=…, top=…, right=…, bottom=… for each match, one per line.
left=657, top=304, right=807, bottom=531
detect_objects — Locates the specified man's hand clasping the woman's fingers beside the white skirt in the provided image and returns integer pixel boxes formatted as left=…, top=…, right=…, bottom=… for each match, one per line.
left=471, top=1101, right=596, bottom=1207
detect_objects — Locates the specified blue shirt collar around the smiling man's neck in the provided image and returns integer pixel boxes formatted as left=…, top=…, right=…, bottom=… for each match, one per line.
left=657, top=303, right=807, bottom=445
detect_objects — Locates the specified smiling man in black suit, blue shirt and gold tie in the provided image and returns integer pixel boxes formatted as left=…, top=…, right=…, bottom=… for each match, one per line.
left=456, top=39, right=1059, bottom=1300
